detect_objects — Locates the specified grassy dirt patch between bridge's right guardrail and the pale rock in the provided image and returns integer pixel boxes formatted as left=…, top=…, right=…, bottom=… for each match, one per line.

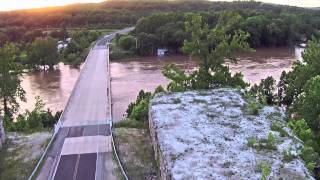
left=114, top=128, right=158, bottom=180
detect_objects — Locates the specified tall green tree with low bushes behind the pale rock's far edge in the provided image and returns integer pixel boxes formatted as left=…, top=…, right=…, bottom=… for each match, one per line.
left=163, top=12, right=251, bottom=91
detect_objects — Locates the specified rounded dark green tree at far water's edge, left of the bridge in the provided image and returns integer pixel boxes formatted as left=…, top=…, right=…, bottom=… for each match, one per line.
left=29, top=37, right=59, bottom=70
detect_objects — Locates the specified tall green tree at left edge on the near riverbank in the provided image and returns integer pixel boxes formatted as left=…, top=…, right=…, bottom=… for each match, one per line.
left=0, top=44, right=26, bottom=117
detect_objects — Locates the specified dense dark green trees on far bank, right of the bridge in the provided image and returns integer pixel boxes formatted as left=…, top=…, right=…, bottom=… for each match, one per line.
left=131, top=10, right=320, bottom=56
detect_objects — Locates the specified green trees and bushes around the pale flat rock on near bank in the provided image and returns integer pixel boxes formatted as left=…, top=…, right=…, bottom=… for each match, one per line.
left=123, top=14, right=320, bottom=178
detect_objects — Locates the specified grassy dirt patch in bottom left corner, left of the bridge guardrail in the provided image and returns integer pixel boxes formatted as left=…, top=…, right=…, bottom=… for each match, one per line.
left=0, top=132, right=51, bottom=180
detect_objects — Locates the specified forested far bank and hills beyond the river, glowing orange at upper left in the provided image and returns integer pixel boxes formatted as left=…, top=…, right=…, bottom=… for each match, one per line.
left=0, top=0, right=320, bottom=59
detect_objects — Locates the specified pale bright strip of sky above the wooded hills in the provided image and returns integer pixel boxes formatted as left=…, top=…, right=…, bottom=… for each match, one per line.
left=0, top=0, right=320, bottom=11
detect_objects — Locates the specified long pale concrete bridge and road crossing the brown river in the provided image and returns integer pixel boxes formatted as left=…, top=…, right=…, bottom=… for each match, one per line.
left=29, top=28, right=133, bottom=180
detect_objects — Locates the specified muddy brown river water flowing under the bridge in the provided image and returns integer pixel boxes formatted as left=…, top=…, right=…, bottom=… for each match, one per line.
left=20, top=48, right=302, bottom=121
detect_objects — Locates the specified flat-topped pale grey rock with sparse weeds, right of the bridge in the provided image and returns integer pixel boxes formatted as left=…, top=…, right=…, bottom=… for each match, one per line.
left=149, top=89, right=313, bottom=180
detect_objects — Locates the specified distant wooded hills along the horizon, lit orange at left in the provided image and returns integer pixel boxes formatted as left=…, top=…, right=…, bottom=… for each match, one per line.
left=0, top=0, right=319, bottom=28
